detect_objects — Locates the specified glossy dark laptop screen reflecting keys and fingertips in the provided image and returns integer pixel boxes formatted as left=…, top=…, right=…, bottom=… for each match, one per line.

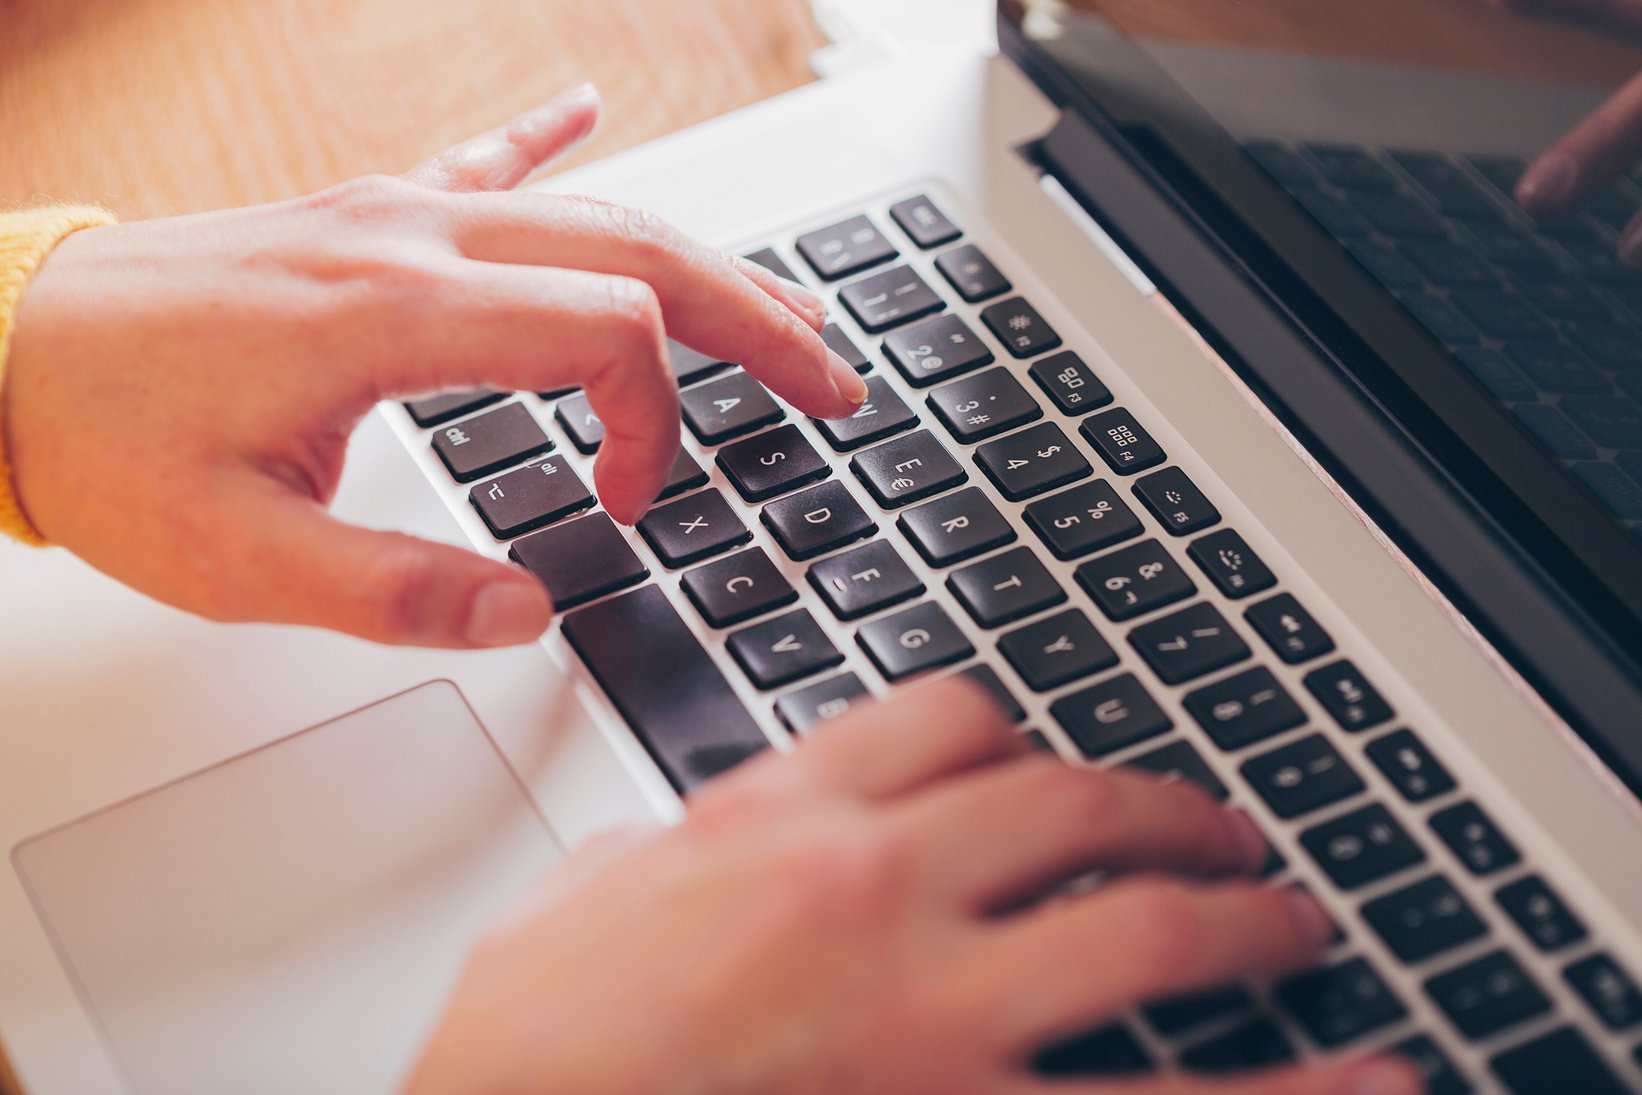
left=1000, top=0, right=1642, bottom=656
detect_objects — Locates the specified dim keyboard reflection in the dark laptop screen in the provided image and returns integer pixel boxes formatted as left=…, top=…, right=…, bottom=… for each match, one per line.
left=1245, top=141, right=1642, bottom=540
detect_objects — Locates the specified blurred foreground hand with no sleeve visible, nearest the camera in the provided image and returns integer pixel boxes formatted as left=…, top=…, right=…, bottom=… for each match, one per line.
left=407, top=681, right=1420, bottom=1095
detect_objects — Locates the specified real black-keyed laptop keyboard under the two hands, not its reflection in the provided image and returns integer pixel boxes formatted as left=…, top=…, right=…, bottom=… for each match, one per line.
left=397, top=186, right=1642, bottom=1095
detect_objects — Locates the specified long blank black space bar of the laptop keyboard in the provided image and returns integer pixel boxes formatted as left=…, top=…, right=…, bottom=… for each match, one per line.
left=561, top=587, right=768, bottom=793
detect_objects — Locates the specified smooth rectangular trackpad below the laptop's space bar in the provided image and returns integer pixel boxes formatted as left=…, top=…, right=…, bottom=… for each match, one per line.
left=13, top=681, right=562, bottom=1095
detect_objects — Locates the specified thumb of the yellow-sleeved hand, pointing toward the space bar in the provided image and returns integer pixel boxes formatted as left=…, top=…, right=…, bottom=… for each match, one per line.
left=234, top=497, right=553, bottom=648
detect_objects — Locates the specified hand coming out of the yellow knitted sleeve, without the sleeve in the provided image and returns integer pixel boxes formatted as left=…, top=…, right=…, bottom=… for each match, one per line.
left=3, top=89, right=865, bottom=647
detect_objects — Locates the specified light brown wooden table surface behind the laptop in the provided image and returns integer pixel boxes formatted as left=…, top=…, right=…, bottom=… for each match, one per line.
left=0, top=0, right=1637, bottom=1092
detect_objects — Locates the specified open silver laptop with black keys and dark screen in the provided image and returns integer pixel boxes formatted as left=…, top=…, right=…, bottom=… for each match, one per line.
left=0, top=0, right=1642, bottom=1095
